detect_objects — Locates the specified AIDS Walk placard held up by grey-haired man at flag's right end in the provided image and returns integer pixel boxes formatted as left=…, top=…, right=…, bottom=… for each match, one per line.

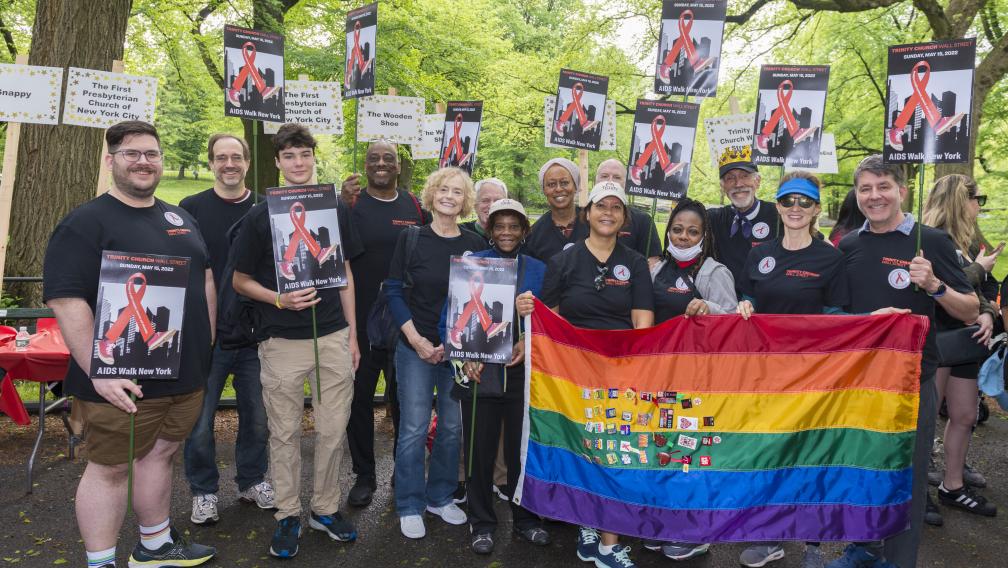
left=882, top=37, right=977, bottom=163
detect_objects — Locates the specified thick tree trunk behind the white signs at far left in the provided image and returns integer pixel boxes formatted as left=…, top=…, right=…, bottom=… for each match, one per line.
left=5, top=0, right=131, bottom=307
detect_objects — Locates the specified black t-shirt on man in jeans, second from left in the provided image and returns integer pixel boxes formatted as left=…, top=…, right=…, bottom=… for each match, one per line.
left=178, top=188, right=255, bottom=290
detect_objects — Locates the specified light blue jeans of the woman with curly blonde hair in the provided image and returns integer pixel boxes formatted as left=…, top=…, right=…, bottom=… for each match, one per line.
left=395, top=341, right=462, bottom=517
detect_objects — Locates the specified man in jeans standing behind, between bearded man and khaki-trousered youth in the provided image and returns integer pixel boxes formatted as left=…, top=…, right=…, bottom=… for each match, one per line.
left=178, top=134, right=273, bottom=525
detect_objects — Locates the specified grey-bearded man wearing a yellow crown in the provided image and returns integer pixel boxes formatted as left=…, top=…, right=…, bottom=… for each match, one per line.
left=708, top=146, right=780, bottom=298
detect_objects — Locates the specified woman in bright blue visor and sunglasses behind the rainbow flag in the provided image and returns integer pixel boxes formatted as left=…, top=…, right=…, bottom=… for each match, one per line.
left=738, top=172, right=850, bottom=566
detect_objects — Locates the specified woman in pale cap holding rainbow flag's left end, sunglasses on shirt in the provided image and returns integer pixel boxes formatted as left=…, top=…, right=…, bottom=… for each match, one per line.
left=516, top=182, right=654, bottom=568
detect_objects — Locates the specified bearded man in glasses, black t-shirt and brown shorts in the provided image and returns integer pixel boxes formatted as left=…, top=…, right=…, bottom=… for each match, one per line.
left=42, top=121, right=216, bottom=568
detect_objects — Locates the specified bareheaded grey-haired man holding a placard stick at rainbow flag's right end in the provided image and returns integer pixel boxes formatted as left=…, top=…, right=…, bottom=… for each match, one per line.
left=839, top=154, right=980, bottom=566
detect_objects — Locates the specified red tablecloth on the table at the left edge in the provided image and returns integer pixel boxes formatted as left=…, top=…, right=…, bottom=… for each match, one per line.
left=0, top=320, right=70, bottom=426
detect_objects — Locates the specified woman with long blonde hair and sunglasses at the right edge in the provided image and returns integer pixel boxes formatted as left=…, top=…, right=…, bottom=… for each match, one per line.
left=921, top=174, right=1004, bottom=525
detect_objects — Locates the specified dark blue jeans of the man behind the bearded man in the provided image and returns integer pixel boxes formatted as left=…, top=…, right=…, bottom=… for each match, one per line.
left=184, top=346, right=269, bottom=495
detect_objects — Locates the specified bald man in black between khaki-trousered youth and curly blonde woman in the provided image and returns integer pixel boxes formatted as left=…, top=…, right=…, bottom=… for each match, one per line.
left=341, top=140, right=429, bottom=506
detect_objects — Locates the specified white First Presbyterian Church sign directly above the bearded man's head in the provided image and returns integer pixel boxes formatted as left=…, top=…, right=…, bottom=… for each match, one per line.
left=64, top=67, right=157, bottom=128
